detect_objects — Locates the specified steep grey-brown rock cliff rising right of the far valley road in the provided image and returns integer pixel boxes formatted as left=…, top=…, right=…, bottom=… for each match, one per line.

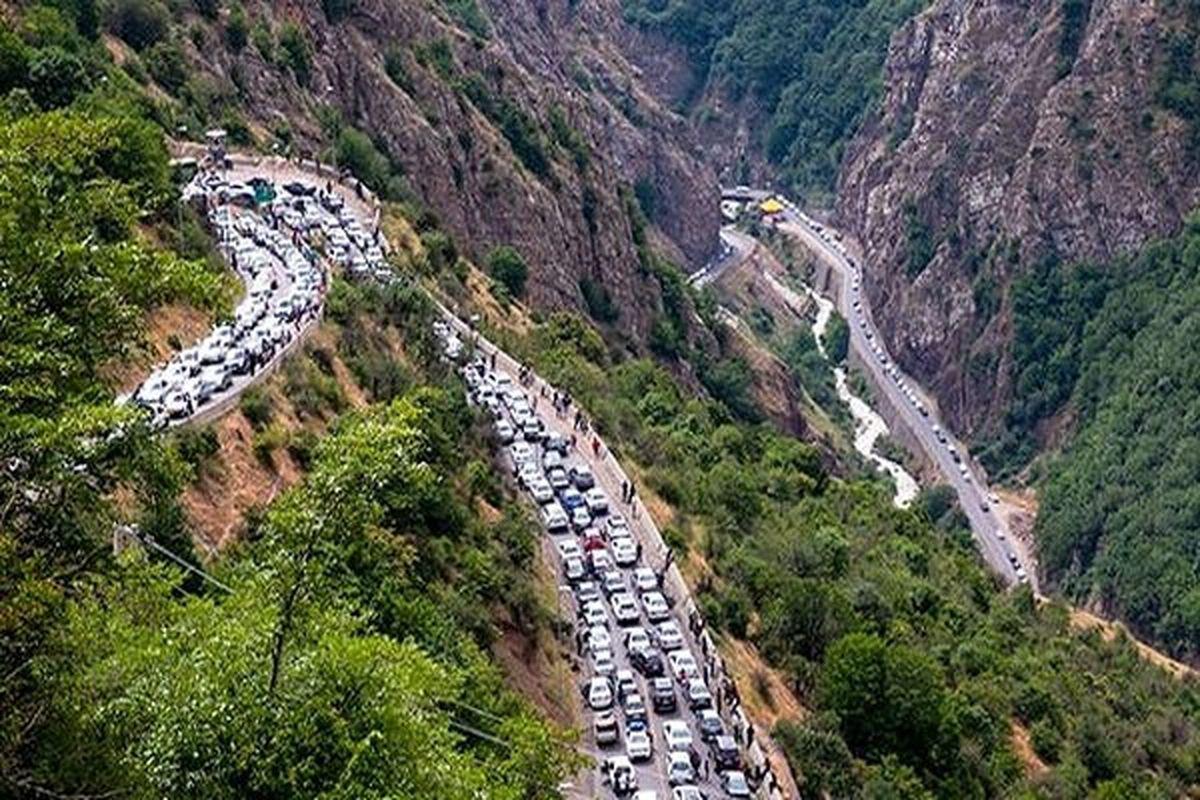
left=838, top=0, right=1200, bottom=432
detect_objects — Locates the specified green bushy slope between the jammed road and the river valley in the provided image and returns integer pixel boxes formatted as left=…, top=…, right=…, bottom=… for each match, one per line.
left=482, top=314, right=1200, bottom=798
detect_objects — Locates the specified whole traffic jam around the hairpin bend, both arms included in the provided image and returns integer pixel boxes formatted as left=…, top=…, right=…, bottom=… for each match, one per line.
left=119, top=170, right=391, bottom=428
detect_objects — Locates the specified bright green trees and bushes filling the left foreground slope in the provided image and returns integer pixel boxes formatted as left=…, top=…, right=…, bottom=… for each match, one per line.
left=0, top=2, right=577, bottom=800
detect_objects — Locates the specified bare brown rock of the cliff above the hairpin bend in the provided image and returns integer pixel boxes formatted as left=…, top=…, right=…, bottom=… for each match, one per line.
left=187, top=0, right=719, bottom=342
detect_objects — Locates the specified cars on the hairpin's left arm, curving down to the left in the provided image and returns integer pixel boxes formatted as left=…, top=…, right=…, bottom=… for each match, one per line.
left=121, top=178, right=325, bottom=427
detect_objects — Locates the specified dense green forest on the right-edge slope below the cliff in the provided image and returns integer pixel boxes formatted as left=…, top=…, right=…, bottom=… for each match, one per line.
left=1008, top=218, right=1200, bottom=657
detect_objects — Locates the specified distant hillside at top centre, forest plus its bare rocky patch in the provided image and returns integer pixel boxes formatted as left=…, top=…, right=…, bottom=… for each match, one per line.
left=622, top=0, right=926, bottom=204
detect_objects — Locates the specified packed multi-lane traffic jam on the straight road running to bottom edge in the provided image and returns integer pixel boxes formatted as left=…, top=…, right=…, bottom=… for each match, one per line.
left=434, top=320, right=754, bottom=800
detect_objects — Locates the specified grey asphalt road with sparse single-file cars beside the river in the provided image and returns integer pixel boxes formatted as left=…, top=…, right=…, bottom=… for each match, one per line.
left=720, top=195, right=1037, bottom=590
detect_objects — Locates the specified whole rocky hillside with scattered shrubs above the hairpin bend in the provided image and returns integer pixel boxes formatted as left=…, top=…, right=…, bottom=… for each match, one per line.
left=119, top=0, right=718, bottom=347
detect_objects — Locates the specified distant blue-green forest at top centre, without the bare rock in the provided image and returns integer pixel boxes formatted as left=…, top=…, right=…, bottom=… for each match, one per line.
left=624, top=0, right=928, bottom=196
